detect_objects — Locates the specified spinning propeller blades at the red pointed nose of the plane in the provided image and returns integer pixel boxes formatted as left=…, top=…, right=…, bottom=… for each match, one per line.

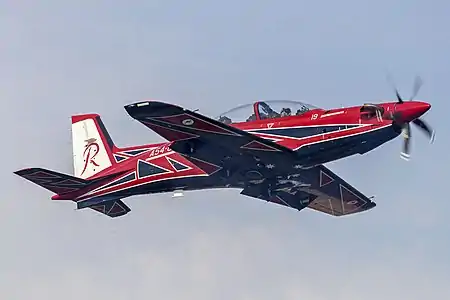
left=384, top=76, right=435, bottom=160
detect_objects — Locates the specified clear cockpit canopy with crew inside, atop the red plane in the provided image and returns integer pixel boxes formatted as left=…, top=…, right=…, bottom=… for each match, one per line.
left=216, top=100, right=317, bottom=124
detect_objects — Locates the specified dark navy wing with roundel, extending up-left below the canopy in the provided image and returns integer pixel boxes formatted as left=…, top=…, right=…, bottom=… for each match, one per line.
left=125, top=101, right=299, bottom=174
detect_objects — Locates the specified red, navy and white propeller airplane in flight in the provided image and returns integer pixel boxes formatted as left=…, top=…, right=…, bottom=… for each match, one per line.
left=14, top=82, right=434, bottom=218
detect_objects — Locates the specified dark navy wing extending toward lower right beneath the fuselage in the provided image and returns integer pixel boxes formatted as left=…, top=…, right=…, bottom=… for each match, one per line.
left=241, top=165, right=376, bottom=216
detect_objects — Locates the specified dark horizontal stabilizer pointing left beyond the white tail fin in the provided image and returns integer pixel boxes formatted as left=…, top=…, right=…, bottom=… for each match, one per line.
left=14, top=168, right=92, bottom=195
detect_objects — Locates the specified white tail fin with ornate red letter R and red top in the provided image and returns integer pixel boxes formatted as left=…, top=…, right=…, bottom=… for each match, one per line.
left=72, top=114, right=115, bottom=179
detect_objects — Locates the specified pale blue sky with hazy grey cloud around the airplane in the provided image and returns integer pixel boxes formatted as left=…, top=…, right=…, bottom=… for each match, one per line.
left=0, top=0, right=450, bottom=300
